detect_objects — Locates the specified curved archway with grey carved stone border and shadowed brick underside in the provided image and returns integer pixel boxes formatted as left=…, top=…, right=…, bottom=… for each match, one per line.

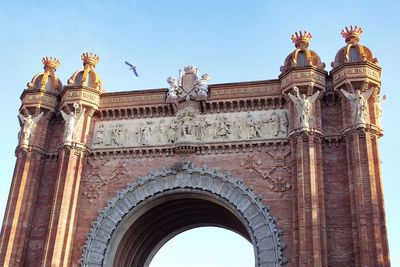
left=81, top=163, right=286, bottom=267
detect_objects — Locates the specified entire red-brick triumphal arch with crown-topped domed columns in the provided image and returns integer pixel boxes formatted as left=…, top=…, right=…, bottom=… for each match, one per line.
left=0, top=27, right=389, bottom=267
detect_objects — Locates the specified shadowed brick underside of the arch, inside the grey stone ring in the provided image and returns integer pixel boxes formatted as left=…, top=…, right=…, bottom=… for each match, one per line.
left=109, top=192, right=252, bottom=267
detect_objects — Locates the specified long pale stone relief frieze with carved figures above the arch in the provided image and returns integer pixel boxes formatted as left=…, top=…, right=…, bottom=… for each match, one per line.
left=92, top=108, right=288, bottom=149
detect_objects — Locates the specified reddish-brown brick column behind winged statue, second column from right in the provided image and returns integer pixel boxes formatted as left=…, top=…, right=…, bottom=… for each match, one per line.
left=289, top=87, right=328, bottom=267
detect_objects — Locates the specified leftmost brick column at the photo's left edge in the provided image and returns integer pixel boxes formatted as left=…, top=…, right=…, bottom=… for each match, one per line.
left=0, top=109, right=53, bottom=267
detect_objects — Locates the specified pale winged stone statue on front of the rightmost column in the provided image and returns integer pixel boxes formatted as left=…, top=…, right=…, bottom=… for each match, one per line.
left=340, top=88, right=374, bottom=124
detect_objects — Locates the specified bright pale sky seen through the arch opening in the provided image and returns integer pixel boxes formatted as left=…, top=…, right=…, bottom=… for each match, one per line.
left=149, top=227, right=254, bottom=267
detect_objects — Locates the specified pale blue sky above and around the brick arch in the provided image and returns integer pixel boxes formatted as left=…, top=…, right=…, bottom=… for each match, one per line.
left=0, top=0, right=400, bottom=267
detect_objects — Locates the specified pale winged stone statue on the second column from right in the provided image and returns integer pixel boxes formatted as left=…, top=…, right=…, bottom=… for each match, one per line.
left=288, top=86, right=319, bottom=128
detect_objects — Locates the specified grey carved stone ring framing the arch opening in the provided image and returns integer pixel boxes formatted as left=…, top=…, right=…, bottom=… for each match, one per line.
left=81, top=162, right=287, bottom=267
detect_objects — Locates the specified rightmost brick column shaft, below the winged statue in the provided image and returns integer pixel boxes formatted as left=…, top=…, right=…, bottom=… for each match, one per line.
left=346, top=127, right=390, bottom=267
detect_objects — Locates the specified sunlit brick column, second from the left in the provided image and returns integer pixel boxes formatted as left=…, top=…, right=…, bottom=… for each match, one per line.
left=43, top=107, right=94, bottom=266
